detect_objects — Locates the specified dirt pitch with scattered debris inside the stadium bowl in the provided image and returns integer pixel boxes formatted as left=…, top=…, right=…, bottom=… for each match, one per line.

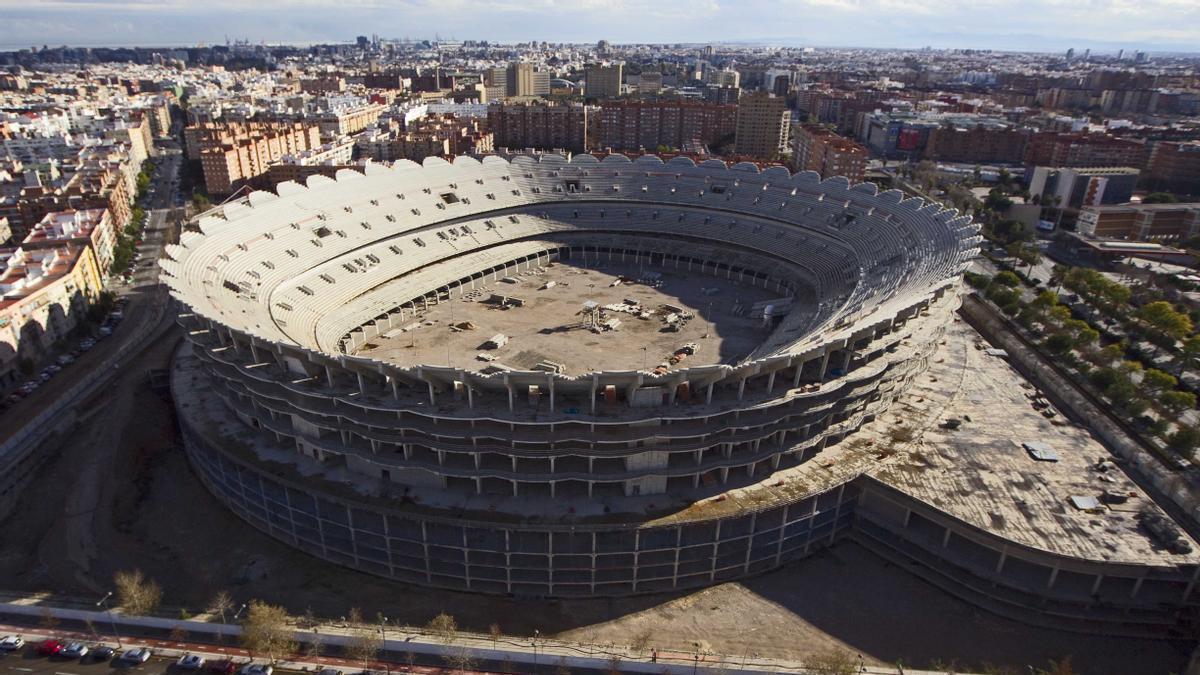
left=359, top=262, right=779, bottom=375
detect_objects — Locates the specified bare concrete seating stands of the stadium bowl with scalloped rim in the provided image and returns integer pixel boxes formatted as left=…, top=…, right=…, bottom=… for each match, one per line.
left=162, top=155, right=979, bottom=377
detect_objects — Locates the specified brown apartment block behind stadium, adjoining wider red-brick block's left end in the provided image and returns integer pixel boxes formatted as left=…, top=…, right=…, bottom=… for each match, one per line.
left=487, top=103, right=588, bottom=153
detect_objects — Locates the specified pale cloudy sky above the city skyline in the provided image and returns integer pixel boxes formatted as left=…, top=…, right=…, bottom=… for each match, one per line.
left=0, top=0, right=1200, bottom=52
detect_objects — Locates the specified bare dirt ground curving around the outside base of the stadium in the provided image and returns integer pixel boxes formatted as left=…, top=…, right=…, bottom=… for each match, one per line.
left=0, top=329, right=1187, bottom=674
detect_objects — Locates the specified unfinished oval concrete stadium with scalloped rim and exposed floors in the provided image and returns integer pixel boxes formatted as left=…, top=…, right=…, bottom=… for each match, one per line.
left=162, top=155, right=978, bottom=597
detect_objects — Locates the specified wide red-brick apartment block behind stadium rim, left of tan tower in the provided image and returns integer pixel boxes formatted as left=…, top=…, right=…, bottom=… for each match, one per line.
left=594, top=101, right=738, bottom=151
